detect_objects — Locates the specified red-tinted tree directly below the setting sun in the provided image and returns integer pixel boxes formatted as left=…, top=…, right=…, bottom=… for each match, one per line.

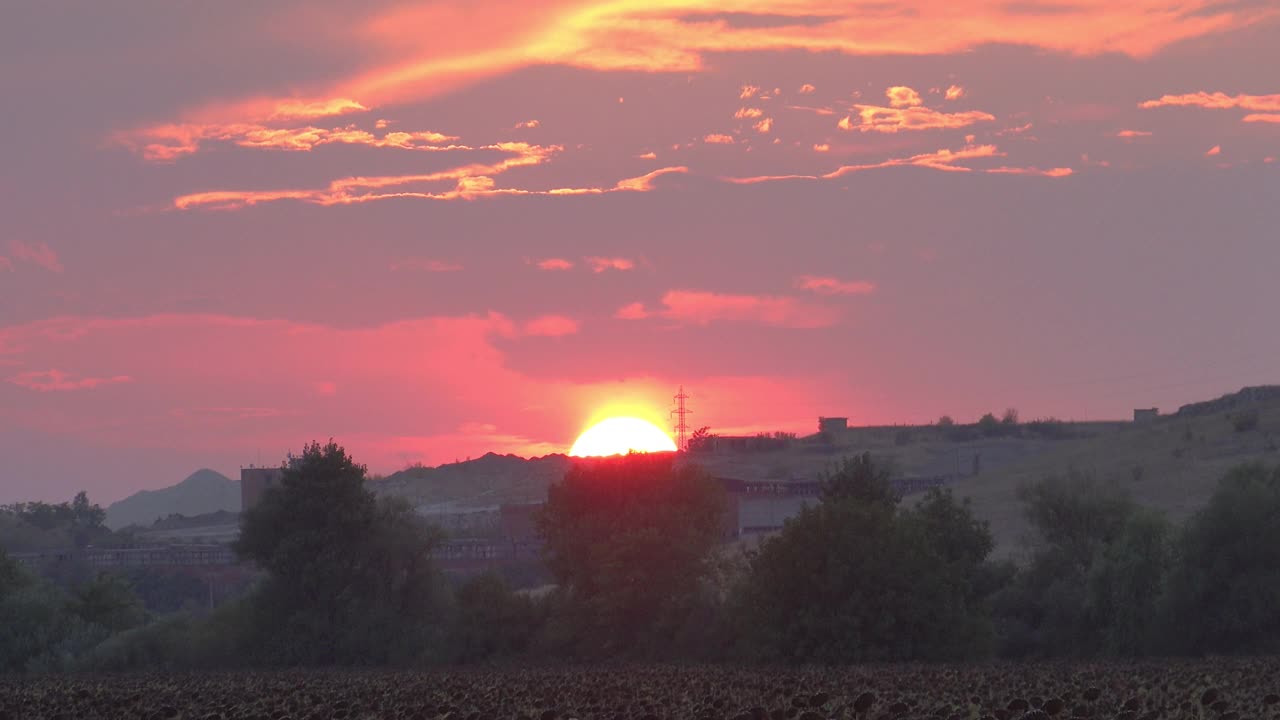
left=538, top=454, right=726, bottom=655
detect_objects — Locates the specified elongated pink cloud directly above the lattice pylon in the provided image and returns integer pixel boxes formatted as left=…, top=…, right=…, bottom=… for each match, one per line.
left=624, top=290, right=840, bottom=328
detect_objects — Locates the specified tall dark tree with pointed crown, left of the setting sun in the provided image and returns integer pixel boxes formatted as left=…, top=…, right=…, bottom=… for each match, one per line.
left=236, top=441, right=439, bottom=664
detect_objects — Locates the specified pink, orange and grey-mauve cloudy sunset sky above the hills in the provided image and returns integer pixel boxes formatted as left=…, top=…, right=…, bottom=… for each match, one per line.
left=0, top=0, right=1280, bottom=502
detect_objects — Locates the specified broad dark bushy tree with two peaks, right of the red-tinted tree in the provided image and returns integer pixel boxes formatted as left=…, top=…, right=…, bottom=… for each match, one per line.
left=739, top=455, right=992, bottom=662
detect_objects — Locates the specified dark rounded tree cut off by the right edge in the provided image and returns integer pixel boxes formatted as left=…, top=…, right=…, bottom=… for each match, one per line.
left=1167, top=464, right=1280, bottom=653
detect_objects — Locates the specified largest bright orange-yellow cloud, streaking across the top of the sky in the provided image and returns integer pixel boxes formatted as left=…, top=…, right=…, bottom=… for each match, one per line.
left=115, top=0, right=1280, bottom=147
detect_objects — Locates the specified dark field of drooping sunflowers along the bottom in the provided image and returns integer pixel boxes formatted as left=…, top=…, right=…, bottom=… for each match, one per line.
left=0, top=657, right=1280, bottom=720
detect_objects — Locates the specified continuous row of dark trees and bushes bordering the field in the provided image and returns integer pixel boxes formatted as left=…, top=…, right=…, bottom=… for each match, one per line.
left=0, top=443, right=1280, bottom=671
